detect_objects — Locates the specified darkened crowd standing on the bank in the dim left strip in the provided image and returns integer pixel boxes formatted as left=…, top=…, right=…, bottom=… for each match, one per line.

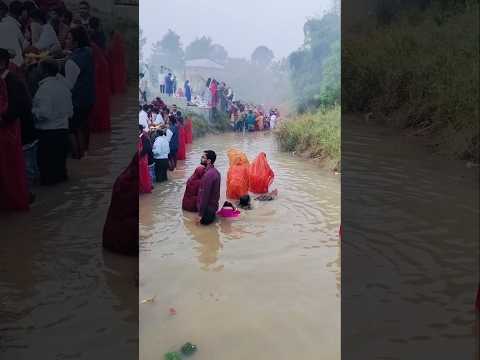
left=0, top=0, right=126, bottom=210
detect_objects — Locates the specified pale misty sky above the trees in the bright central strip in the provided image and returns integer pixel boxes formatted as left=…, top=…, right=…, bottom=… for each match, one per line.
left=140, top=0, right=332, bottom=58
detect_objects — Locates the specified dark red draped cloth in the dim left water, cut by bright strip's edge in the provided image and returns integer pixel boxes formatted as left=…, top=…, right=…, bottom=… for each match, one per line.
left=103, top=154, right=138, bottom=256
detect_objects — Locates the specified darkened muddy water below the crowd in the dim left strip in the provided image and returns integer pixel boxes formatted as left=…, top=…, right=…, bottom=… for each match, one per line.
left=0, top=90, right=138, bottom=360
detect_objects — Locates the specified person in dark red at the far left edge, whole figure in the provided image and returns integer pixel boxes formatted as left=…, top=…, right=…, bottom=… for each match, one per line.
left=0, top=49, right=29, bottom=210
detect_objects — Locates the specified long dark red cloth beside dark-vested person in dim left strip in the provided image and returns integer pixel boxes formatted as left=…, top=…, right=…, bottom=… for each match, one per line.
left=90, top=43, right=111, bottom=132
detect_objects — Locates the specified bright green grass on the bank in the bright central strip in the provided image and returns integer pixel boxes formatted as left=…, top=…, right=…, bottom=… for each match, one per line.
left=276, top=106, right=341, bottom=169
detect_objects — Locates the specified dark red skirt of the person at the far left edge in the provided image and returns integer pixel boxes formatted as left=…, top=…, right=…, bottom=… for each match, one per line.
left=0, top=120, right=29, bottom=210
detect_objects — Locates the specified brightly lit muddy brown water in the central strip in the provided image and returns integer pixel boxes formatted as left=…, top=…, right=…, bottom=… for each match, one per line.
left=139, top=133, right=340, bottom=360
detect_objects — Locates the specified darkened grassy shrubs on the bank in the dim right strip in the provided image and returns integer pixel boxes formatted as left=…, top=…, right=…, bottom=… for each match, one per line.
left=342, top=1, right=479, bottom=160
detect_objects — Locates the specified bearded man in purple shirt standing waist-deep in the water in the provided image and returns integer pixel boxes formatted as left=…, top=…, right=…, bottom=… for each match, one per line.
left=197, top=150, right=221, bottom=225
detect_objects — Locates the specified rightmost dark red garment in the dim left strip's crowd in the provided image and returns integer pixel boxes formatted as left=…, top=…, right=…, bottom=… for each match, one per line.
left=108, top=32, right=127, bottom=94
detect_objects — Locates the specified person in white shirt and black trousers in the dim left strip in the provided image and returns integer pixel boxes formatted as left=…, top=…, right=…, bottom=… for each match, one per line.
left=32, top=60, right=73, bottom=185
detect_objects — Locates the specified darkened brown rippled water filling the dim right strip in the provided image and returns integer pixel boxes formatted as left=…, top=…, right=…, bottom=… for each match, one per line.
left=341, top=117, right=480, bottom=360
